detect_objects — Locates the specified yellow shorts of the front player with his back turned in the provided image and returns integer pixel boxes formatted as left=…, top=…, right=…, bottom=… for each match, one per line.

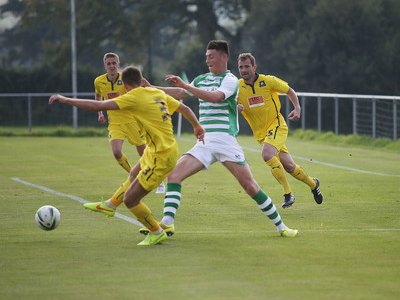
left=136, top=144, right=179, bottom=191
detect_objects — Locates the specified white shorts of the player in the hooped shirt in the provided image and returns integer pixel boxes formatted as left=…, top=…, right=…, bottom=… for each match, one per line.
left=185, top=132, right=246, bottom=169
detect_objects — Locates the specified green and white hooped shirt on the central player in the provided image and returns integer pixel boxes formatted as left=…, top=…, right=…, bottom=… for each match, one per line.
left=191, top=70, right=239, bottom=136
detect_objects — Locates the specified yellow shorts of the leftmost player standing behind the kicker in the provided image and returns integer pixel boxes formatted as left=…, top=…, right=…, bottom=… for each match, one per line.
left=108, top=122, right=146, bottom=146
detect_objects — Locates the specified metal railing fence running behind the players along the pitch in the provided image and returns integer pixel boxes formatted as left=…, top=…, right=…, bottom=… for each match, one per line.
left=0, top=93, right=400, bottom=140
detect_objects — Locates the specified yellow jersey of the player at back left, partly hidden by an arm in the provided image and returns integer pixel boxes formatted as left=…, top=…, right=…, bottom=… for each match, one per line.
left=94, top=73, right=135, bottom=124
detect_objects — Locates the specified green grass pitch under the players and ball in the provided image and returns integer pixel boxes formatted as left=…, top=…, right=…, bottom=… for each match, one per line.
left=0, top=135, right=400, bottom=300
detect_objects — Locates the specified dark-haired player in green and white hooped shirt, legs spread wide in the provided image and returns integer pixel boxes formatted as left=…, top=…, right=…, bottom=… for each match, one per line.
left=140, top=40, right=298, bottom=237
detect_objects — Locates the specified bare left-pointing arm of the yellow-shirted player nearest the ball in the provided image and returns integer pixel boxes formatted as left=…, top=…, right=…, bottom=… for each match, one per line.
left=49, top=94, right=119, bottom=111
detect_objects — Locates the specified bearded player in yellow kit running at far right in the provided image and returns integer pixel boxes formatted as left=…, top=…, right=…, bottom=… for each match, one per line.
left=238, top=53, right=323, bottom=208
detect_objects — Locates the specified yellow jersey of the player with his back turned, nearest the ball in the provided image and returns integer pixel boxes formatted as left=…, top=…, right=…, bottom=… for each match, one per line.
left=113, top=87, right=180, bottom=153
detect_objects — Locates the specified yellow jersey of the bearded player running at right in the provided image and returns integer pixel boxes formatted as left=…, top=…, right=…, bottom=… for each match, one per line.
left=237, top=74, right=289, bottom=141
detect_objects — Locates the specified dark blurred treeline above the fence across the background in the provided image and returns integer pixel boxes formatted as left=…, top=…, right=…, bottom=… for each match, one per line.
left=0, top=0, right=400, bottom=95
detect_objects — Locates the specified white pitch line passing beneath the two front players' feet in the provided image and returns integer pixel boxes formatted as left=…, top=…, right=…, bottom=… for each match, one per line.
left=11, top=177, right=400, bottom=234
